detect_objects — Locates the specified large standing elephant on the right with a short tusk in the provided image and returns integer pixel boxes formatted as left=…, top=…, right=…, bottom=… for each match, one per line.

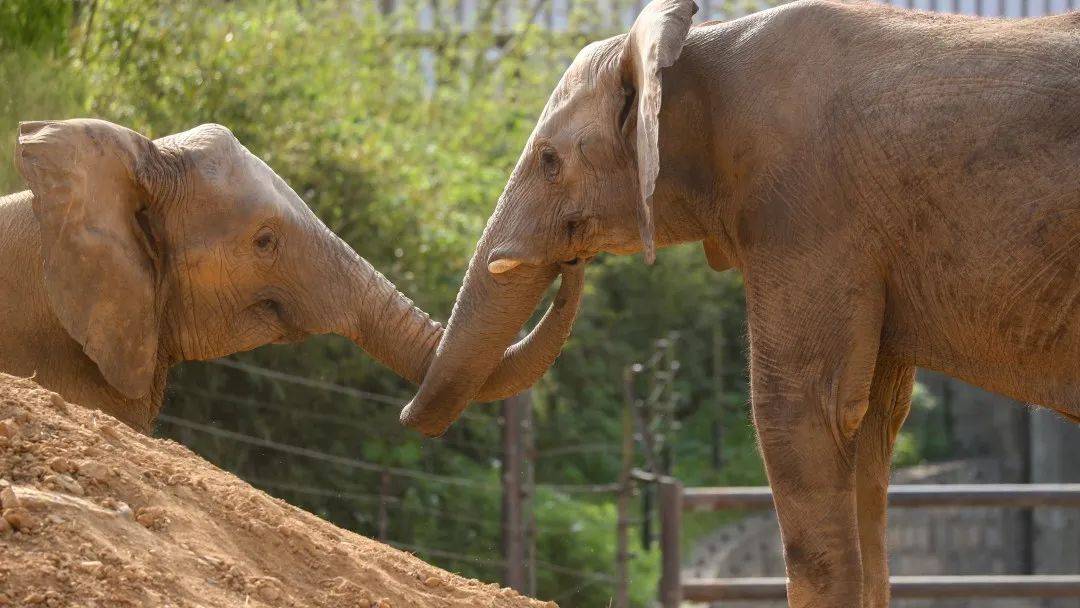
left=402, top=0, right=1080, bottom=608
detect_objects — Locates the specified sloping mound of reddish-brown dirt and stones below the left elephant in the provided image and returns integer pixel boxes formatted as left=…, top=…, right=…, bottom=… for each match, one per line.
left=0, top=374, right=555, bottom=608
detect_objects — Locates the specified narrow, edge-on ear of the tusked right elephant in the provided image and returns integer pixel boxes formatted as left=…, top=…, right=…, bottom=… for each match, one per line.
left=622, top=0, right=698, bottom=264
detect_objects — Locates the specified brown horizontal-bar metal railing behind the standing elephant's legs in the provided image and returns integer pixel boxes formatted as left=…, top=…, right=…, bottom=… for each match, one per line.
left=658, top=477, right=1080, bottom=608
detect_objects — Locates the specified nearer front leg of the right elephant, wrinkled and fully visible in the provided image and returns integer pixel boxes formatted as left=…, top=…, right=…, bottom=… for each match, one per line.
left=747, top=273, right=883, bottom=608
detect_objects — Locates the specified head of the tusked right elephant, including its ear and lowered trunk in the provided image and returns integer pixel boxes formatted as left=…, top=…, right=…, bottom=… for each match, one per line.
left=402, top=0, right=697, bottom=435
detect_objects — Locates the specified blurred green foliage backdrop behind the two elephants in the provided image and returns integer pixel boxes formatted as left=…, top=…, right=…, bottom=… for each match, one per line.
left=0, top=0, right=1080, bottom=607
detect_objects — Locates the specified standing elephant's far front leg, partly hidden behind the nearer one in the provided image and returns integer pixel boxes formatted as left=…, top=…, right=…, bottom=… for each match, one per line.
left=855, top=361, right=915, bottom=608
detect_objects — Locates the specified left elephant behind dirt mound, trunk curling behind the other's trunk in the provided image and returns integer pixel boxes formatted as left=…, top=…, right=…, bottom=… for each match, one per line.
left=0, top=119, right=583, bottom=432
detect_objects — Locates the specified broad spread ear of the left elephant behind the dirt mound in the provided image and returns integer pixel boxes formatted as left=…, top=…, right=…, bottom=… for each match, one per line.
left=15, top=120, right=158, bottom=398
